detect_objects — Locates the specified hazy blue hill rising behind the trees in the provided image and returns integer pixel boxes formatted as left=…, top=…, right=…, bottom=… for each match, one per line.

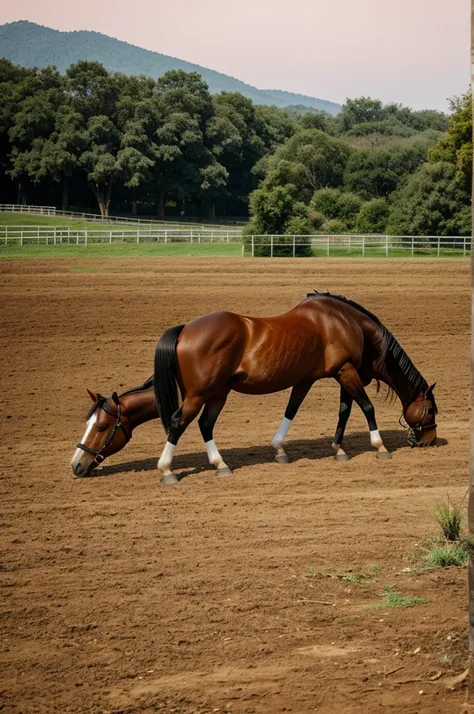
left=0, top=21, right=341, bottom=114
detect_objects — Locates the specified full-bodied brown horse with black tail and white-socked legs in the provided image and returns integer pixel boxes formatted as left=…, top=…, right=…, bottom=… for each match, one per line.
left=154, top=292, right=437, bottom=483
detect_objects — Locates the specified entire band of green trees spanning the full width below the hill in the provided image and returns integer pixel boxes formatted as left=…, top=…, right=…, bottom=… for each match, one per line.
left=0, top=60, right=472, bottom=235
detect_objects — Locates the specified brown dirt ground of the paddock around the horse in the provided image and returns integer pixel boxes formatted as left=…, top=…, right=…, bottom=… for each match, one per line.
left=0, top=258, right=470, bottom=714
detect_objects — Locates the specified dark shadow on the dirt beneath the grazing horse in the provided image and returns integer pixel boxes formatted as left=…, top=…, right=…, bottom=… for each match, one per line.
left=92, top=429, right=448, bottom=480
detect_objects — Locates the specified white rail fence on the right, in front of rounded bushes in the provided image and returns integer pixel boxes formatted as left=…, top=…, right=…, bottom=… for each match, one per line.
left=245, top=234, right=471, bottom=258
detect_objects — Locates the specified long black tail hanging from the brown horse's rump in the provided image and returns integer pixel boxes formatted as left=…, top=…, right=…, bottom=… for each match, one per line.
left=154, top=325, right=184, bottom=434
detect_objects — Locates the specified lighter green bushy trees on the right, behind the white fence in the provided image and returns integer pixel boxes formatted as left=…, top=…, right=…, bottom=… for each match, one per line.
left=246, top=92, right=472, bottom=254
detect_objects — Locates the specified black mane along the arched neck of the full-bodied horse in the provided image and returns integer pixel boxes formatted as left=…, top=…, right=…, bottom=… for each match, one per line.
left=306, top=291, right=434, bottom=404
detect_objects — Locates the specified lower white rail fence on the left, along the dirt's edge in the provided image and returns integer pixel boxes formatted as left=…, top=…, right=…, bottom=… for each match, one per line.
left=0, top=226, right=242, bottom=248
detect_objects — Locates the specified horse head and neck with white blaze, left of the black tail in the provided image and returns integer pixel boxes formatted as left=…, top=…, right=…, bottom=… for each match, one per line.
left=71, top=377, right=160, bottom=476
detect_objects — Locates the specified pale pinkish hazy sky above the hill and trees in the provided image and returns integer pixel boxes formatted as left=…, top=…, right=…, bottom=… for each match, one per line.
left=0, top=0, right=470, bottom=109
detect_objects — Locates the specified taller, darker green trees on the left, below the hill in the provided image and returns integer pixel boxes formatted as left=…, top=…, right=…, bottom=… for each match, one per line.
left=0, top=60, right=295, bottom=217
